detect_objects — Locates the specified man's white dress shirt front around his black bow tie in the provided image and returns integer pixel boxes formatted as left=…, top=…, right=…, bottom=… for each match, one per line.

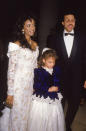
left=63, top=30, right=74, bottom=57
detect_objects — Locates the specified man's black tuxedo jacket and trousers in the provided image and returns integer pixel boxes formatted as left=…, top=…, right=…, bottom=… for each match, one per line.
left=47, top=32, right=85, bottom=127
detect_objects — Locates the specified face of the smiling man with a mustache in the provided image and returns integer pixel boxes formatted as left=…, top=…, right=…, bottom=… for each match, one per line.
left=62, top=14, right=75, bottom=32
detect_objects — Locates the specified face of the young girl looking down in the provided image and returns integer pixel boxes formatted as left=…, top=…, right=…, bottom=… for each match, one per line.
left=43, top=57, right=55, bottom=69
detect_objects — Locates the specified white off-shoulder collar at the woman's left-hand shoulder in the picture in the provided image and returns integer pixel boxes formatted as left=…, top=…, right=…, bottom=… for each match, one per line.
left=7, top=42, right=20, bottom=57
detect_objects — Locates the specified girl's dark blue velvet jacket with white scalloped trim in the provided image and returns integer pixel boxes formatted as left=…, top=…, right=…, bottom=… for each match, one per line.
left=33, top=67, right=60, bottom=99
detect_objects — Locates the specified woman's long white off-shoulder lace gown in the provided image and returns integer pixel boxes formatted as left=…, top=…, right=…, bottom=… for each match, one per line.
left=0, top=42, right=39, bottom=131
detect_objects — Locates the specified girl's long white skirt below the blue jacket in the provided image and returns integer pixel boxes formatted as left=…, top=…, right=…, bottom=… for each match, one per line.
left=28, top=92, right=65, bottom=131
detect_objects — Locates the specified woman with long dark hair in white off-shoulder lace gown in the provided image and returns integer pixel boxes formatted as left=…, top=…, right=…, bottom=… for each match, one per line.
left=0, top=14, right=39, bottom=131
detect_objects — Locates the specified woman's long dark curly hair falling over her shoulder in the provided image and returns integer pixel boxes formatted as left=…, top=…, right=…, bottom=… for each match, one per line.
left=13, top=14, right=35, bottom=49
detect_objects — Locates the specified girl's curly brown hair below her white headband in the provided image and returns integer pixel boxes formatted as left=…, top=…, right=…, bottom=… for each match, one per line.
left=38, top=49, right=58, bottom=68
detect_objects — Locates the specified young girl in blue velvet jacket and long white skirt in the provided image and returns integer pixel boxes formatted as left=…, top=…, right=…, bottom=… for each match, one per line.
left=28, top=48, right=64, bottom=131
